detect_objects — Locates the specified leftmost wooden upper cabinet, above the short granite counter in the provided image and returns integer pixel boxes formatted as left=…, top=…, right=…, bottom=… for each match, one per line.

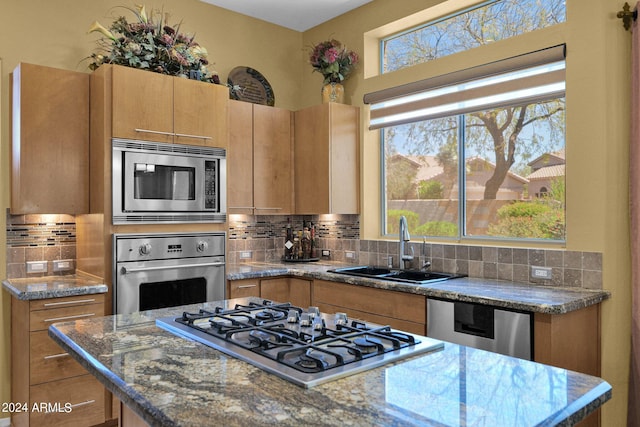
left=11, top=63, right=89, bottom=215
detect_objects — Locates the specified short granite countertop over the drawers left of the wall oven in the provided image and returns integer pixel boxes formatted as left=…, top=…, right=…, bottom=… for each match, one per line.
left=2, top=274, right=109, bottom=301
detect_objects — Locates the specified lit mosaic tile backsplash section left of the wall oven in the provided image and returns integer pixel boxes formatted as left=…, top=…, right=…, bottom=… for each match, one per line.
left=6, top=210, right=76, bottom=279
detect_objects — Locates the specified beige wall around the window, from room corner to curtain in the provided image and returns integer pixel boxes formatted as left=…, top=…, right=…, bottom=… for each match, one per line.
left=300, top=0, right=631, bottom=426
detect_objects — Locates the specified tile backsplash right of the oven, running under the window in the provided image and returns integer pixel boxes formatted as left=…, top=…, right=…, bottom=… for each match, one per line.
left=227, top=215, right=602, bottom=289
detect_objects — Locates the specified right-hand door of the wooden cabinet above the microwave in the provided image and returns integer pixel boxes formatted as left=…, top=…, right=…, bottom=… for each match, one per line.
left=173, top=78, right=229, bottom=148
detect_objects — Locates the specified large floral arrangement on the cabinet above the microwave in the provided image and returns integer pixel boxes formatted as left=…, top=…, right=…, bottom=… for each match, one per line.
left=88, top=5, right=220, bottom=84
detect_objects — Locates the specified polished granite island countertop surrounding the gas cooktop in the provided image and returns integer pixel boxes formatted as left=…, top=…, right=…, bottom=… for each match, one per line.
left=48, top=300, right=612, bottom=427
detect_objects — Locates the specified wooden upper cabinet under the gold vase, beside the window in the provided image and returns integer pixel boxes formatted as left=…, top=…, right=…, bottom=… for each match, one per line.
left=294, top=103, right=360, bottom=214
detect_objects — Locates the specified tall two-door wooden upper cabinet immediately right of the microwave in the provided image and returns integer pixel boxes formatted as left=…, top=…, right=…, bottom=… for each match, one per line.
left=227, top=101, right=293, bottom=215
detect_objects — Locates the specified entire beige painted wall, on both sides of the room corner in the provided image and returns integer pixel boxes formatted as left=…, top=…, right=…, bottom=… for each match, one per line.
left=0, top=0, right=631, bottom=426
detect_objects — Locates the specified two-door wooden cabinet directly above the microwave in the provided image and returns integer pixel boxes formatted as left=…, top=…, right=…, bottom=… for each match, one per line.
left=112, top=66, right=229, bottom=148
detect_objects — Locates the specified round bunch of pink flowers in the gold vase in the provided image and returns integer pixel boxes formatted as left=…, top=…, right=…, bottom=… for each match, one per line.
left=309, top=39, right=359, bottom=84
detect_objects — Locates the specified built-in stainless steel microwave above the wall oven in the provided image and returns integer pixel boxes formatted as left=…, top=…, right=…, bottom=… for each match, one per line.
left=112, top=138, right=227, bottom=224
